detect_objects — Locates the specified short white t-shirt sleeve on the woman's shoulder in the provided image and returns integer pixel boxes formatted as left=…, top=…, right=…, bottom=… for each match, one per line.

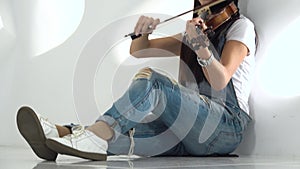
left=226, top=17, right=256, bottom=55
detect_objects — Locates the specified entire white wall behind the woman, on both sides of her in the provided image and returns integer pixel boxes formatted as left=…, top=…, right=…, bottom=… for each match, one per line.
left=0, top=0, right=300, bottom=156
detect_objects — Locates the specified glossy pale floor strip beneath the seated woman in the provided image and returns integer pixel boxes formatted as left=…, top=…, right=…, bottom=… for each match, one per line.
left=0, top=147, right=300, bottom=169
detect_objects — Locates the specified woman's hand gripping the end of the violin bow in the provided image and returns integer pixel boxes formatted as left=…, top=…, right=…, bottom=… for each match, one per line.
left=134, top=15, right=160, bottom=36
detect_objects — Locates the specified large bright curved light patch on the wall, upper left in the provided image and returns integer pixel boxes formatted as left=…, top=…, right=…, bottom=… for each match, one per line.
left=31, top=0, right=85, bottom=56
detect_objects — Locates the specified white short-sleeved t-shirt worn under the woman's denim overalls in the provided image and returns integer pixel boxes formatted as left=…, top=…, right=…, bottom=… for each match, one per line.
left=226, top=15, right=256, bottom=114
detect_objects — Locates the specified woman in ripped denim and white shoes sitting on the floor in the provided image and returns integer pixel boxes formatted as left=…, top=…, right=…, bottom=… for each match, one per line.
left=17, top=0, right=256, bottom=160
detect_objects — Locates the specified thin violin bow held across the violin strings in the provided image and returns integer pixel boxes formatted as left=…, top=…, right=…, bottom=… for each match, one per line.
left=125, top=0, right=226, bottom=40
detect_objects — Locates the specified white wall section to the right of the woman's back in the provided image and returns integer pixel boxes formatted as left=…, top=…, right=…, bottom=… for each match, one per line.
left=233, top=0, right=300, bottom=155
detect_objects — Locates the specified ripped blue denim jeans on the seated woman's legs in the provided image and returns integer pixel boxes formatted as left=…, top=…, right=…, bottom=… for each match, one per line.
left=97, top=68, right=251, bottom=156
